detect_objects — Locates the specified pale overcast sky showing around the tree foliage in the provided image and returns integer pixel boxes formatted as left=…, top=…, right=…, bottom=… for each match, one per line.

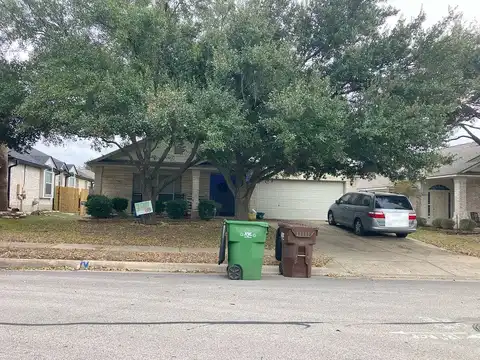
left=35, top=0, right=480, bottom=166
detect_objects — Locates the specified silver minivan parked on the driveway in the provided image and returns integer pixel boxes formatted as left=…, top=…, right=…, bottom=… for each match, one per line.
left=328, top=192, right=417, bottom=238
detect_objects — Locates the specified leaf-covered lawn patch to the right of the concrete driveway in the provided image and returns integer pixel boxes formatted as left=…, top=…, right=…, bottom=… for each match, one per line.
left=410, top=228, right=480, bottom=257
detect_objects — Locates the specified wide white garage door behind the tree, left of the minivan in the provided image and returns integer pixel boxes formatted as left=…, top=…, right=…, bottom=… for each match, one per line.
left=250, top=180, right=343, bottom=220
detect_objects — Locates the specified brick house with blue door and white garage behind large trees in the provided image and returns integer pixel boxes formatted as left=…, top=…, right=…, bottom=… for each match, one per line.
left=88, top=146, right=349, bottom=220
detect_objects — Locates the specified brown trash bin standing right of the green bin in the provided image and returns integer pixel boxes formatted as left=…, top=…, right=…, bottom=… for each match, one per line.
left=278, top=223, right=318, bottom=278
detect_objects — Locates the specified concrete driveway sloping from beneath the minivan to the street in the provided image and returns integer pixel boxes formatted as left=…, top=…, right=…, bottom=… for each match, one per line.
left=314, top=222, right=480, bottom=279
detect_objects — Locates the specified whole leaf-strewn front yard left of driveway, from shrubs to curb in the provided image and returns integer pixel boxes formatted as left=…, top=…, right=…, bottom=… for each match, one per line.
left=0, top=213, right=329, bottom=266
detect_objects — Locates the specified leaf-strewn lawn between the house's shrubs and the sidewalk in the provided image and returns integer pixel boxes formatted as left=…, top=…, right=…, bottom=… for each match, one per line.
left=0, top=215, right=275, bottom=249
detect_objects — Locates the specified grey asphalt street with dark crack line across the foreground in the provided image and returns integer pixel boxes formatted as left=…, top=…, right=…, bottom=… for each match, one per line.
left=0, top=271, right=480, bottom=360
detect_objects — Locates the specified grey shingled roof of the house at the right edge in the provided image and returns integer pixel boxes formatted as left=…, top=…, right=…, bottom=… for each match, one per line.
left=428, top=142, right=480, bottom=177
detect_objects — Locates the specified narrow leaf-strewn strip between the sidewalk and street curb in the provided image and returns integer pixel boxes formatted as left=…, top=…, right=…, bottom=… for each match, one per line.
left=0, top=248, right=330, bottom=267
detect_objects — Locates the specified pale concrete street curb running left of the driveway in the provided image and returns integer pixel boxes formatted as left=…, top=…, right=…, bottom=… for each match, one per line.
left=0, top=258, right=329, bottom=276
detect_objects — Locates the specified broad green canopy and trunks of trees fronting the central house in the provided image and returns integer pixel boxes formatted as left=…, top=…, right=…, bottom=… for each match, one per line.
left=0, top=0, right=480, bottom=217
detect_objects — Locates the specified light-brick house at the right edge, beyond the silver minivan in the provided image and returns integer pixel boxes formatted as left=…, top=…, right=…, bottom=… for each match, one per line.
left=354, top=142, right=480, bottom=223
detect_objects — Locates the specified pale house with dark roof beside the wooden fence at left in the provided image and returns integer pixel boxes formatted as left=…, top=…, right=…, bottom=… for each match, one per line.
left=8, top=149, right=94, bottom=212
